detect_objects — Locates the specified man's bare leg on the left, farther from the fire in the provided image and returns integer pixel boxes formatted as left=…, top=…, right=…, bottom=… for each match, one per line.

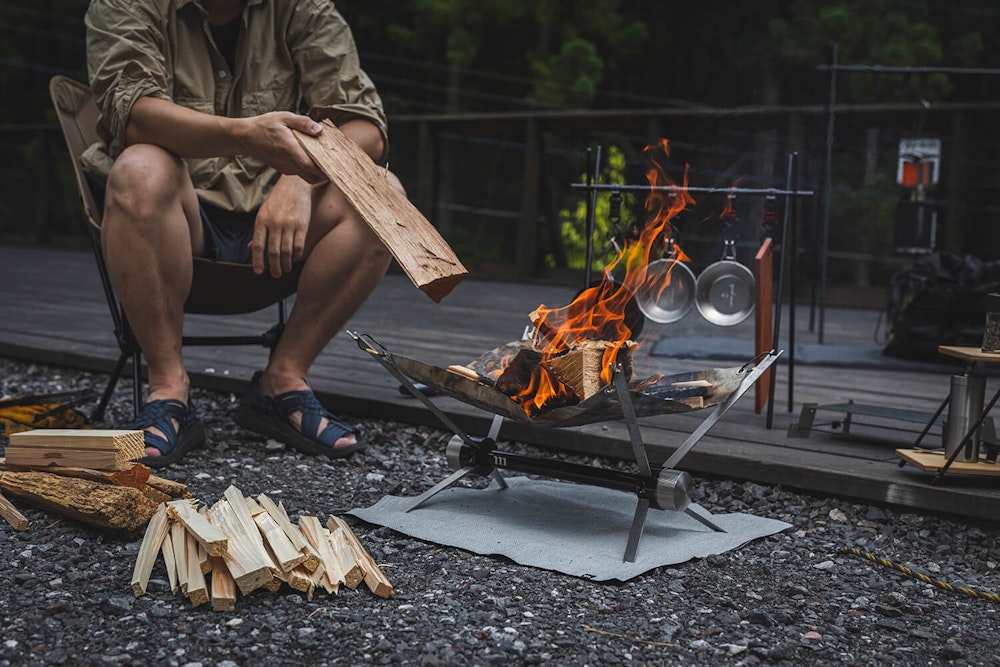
left=101, top=144, right=205, bottom=456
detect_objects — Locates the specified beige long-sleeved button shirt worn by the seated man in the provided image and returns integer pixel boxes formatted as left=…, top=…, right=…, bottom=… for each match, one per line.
left=86, top=0, right=388, bottom=211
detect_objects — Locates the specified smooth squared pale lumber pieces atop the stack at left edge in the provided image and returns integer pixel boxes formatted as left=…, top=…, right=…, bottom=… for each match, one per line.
left=6, top=428, right=146, bottom=470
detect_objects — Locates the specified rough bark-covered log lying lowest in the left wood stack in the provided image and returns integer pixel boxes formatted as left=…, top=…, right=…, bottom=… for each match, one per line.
left=0, top=471, right=157, bottom=531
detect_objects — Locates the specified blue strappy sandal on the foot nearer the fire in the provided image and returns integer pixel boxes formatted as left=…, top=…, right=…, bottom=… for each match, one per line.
left=233, top=371, right=365, bottom=458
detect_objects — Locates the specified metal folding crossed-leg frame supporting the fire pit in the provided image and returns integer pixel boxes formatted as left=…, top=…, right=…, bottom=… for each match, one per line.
left=348, top=332, right=781, bottom=563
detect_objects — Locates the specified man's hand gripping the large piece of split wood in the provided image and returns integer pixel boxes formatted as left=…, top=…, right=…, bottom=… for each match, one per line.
left=241, top=111, right=326, bottom=183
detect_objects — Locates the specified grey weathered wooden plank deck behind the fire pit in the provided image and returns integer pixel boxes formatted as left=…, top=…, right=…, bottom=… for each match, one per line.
left=0, top=246, right=1000, bottom=520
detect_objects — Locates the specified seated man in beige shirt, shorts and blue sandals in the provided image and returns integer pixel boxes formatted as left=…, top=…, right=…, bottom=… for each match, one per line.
left=86, top=0, right=402, bottom=466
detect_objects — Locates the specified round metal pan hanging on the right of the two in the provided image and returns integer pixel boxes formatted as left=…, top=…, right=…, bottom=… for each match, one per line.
left=695, top=239, right=754, bottom=327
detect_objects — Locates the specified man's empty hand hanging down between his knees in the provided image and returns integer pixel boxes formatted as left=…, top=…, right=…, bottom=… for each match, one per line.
left=250, top=176, right=312, bottom=278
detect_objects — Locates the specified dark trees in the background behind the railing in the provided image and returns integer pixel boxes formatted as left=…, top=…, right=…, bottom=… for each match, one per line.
left=0, top=0, right=1000, bottom=296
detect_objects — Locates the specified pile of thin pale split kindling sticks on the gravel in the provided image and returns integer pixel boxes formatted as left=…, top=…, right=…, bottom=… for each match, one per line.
left=132, top=486, right=393, bottom=611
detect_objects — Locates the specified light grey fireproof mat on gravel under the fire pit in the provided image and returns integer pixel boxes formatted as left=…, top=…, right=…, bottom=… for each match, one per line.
left=350, top=477, right=791, bottom=581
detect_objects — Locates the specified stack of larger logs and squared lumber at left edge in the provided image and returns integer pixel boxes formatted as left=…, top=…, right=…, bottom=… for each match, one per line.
left=0, top=429, right=189, bottom=532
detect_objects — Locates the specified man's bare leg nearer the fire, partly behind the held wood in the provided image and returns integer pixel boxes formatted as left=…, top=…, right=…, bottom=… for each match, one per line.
left=254, top=174, right=402, bottom=446
